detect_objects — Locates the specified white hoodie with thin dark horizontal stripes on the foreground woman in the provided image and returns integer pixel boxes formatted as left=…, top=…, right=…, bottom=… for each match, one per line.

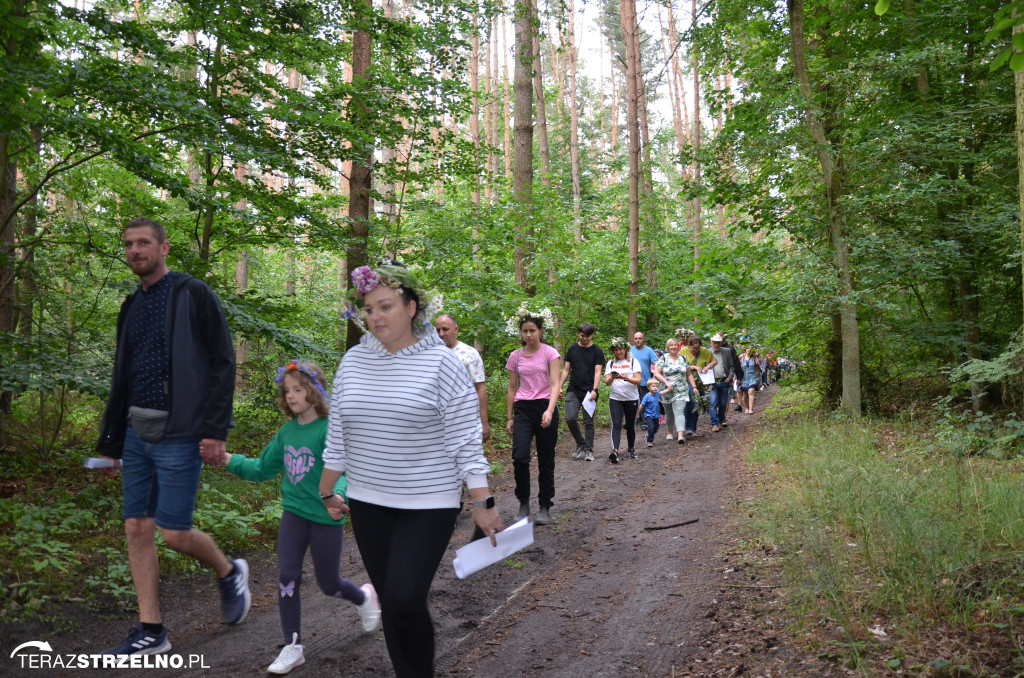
left=324, top=326, right=490, bottom=509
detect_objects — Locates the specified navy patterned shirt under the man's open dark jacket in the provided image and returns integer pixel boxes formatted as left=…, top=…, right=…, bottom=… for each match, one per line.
left=125, top=274, right=174, bottom=410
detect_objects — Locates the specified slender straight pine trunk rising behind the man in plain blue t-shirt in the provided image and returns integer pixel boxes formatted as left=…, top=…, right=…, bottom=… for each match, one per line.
left=618, top=0, right=640, bottom=337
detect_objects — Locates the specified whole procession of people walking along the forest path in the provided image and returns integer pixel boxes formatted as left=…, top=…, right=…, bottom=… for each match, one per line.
left=90, top=218, right=780, bottom=678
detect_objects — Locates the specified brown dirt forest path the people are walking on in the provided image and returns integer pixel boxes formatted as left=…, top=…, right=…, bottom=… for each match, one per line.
left=12, top=389, right=823, bottom=678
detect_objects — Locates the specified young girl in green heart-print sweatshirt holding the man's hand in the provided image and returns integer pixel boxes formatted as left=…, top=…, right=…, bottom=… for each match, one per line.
left=205, top=361, right=381, bottom=675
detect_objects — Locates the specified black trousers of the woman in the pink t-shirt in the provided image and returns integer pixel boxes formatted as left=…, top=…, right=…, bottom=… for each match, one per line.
left=512, top=399, right=558, bottom=508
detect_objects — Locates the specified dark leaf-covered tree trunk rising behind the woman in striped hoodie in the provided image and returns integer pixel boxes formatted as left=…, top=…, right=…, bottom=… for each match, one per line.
left=345, top=0, right=374, bottom=348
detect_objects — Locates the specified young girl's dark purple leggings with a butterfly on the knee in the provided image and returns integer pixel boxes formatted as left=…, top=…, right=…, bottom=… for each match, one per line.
left=278, top=511, right=366, bottom=645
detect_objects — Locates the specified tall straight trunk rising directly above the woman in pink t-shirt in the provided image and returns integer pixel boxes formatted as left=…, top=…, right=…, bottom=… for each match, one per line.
left=512, top=0, right=535, bottom=296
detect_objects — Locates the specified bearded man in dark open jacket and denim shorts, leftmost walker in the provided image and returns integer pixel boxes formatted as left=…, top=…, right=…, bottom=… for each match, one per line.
left=97, top=217, right=251, bottom=654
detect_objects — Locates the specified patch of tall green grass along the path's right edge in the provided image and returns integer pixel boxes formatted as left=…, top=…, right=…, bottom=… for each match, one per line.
left=750, top=390, right=1024, bottom=668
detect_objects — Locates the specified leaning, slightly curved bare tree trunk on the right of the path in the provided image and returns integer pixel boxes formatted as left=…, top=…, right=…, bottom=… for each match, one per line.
left=790, top=0, right=860, bottom=417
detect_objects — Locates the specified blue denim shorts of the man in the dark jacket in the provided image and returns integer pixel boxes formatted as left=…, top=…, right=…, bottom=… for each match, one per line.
left=121, top=423, right=203, bottom=529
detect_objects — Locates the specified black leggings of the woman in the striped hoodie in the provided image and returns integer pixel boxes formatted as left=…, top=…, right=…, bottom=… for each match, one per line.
left=348, top=499, right=459, bottom=678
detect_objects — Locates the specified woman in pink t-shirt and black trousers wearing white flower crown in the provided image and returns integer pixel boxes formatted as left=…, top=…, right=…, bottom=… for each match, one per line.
left=505, top=311, right=560, bottom=525
